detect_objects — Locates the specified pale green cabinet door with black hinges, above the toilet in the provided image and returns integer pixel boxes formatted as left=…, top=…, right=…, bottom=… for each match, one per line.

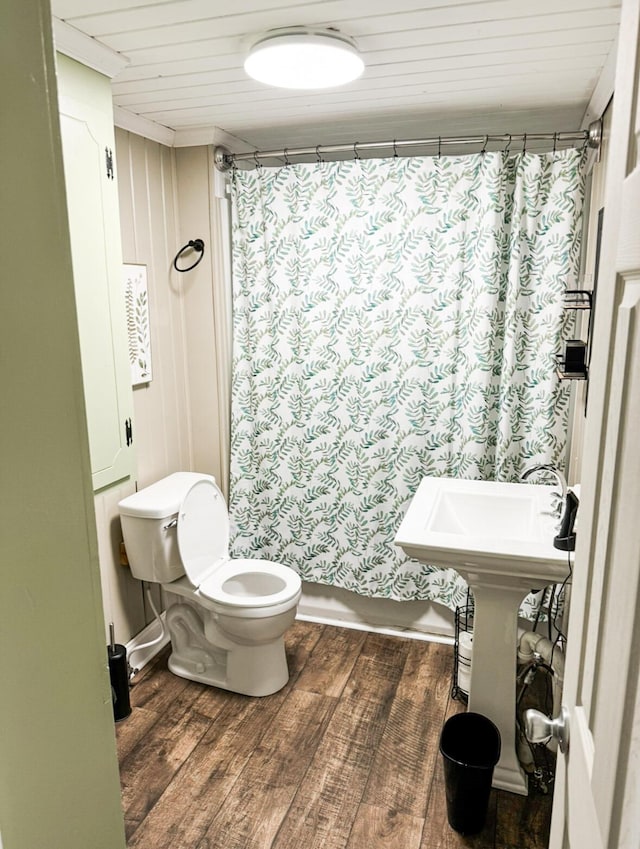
left=57, top=55, right=133, bottom=490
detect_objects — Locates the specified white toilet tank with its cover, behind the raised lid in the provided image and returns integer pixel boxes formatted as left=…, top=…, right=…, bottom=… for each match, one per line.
left=118, top=472, right=215, bottom=583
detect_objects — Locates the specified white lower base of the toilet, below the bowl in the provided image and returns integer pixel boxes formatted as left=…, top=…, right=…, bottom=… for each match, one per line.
left=167, top=602, right=289, bottom=696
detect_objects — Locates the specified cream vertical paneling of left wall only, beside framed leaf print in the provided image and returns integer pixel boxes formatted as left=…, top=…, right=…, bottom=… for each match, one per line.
left=95, top=130, right=189, bottom=642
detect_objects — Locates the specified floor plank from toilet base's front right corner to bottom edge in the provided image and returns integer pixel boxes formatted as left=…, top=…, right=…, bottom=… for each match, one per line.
left=197, top=689, right=336, bottom=849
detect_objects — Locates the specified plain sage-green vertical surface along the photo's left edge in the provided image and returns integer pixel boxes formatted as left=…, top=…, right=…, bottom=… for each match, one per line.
left=0, top=0, right=125, bottom=849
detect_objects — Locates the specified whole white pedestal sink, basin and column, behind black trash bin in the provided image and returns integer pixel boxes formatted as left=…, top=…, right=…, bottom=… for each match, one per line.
left=395, top=478, right=567, bottom=795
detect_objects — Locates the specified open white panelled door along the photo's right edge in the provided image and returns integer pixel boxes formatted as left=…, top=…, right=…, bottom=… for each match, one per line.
left=550, top=0, right=640, bottom=849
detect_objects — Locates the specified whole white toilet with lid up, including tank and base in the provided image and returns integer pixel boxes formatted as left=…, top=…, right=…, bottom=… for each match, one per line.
left=118, top=472, right=301, bottom=696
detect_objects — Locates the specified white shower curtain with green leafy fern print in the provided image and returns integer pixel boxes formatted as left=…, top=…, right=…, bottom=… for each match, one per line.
left=230, top=150, right=583, bottom=617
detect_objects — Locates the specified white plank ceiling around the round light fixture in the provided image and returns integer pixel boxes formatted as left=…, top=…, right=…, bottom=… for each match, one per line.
left=52, top=0, right=620, bottom=150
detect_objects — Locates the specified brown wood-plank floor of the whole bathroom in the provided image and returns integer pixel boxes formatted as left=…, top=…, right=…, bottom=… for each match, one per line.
left=117, top=622, right=551, bottom=849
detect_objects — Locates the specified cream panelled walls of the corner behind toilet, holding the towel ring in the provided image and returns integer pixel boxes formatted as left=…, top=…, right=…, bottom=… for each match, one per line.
left=95, top=129, right=228, bottom=643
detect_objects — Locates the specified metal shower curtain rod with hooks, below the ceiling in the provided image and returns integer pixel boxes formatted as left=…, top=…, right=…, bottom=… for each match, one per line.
left=214, top=120, right=602, bottom=171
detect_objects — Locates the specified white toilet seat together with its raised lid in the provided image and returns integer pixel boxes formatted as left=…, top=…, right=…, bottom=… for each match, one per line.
left=177, top=479, right=300, bottom=618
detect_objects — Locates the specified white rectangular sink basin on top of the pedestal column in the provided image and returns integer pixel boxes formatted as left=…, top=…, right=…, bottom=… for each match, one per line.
left=395, top=478, right=567, bottom=588
